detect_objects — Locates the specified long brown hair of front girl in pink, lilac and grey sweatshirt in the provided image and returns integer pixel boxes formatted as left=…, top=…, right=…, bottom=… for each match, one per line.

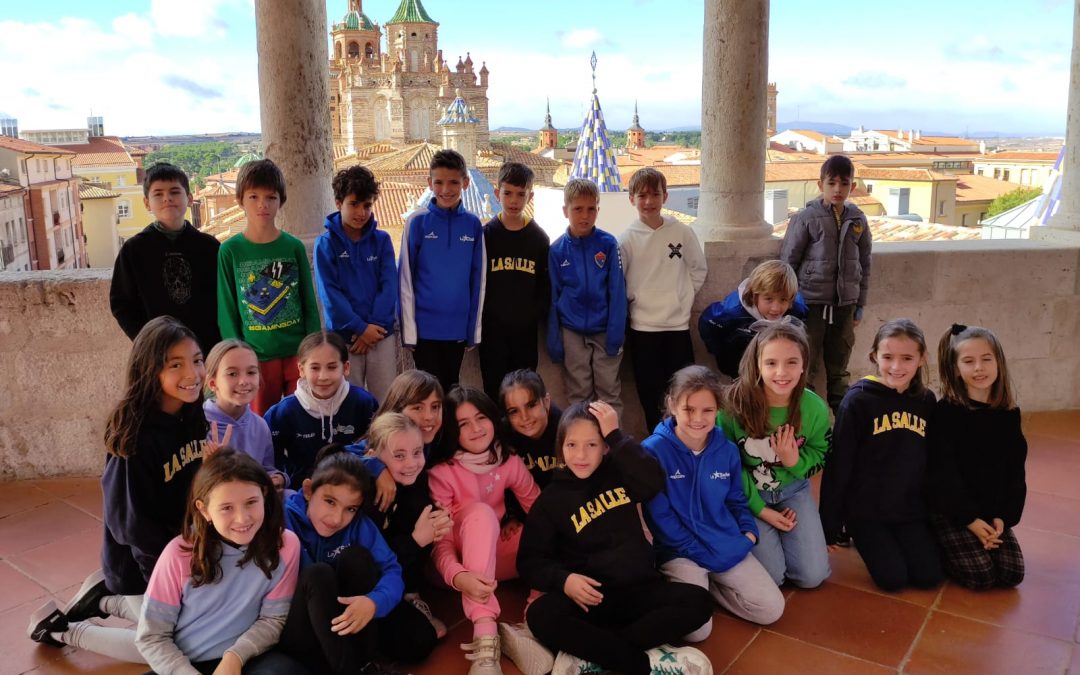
left=181, top=447, right=285, bottom=586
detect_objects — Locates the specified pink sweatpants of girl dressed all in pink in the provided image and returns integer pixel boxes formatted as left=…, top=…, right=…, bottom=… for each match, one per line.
left=454, top=501, right=522, bottom=623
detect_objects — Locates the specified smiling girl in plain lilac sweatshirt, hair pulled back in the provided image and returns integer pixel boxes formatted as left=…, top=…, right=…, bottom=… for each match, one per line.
left=203, top=338, right=288, bottom=490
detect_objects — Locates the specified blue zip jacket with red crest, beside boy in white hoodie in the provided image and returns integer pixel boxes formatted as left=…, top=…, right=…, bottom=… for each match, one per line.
left=548, top=228, right=626, bottom=363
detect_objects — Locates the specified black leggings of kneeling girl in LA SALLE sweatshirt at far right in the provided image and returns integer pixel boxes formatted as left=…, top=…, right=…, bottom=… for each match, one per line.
left=848, top=521, right=945, bottom=591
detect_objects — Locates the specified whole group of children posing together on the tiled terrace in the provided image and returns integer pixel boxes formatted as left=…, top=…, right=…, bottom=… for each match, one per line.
left=23, top=152, right=1026, bottom=675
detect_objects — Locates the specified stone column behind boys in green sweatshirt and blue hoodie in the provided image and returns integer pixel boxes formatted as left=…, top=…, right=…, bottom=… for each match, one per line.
left=255, top=0, right=334, bottom=241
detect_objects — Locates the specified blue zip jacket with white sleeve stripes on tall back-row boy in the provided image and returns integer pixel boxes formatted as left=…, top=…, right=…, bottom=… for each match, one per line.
left=397, top=198, right=486, bottom=347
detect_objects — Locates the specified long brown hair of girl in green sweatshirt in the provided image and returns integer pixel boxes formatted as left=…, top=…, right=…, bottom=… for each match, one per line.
left=724, top=321, right=810, bottom=438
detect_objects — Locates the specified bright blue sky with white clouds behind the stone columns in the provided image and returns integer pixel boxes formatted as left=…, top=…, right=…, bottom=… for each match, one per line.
left=0, top=0, right=1072, bottom=135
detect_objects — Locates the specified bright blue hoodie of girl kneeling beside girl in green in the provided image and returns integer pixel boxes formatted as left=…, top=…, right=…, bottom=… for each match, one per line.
left=642, top=417, right=758, bottom=572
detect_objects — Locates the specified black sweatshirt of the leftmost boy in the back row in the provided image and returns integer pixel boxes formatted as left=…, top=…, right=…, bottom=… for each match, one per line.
left=109, top=222, right=221, bottom=354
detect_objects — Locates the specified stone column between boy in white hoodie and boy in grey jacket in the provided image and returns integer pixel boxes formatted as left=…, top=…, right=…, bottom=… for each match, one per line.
left=693, top=0, right=772, bottom=242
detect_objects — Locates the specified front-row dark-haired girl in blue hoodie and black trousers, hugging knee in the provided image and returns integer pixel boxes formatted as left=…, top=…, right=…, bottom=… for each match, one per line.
left=281, top=444, right=435, bottom=675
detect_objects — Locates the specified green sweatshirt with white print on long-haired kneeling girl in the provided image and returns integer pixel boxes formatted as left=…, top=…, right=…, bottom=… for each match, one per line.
left=716, top=389, right=833, bottom=515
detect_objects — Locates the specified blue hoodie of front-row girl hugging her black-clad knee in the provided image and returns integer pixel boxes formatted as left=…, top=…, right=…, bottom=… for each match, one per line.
left=285, top=490, right=405, bottom=619
